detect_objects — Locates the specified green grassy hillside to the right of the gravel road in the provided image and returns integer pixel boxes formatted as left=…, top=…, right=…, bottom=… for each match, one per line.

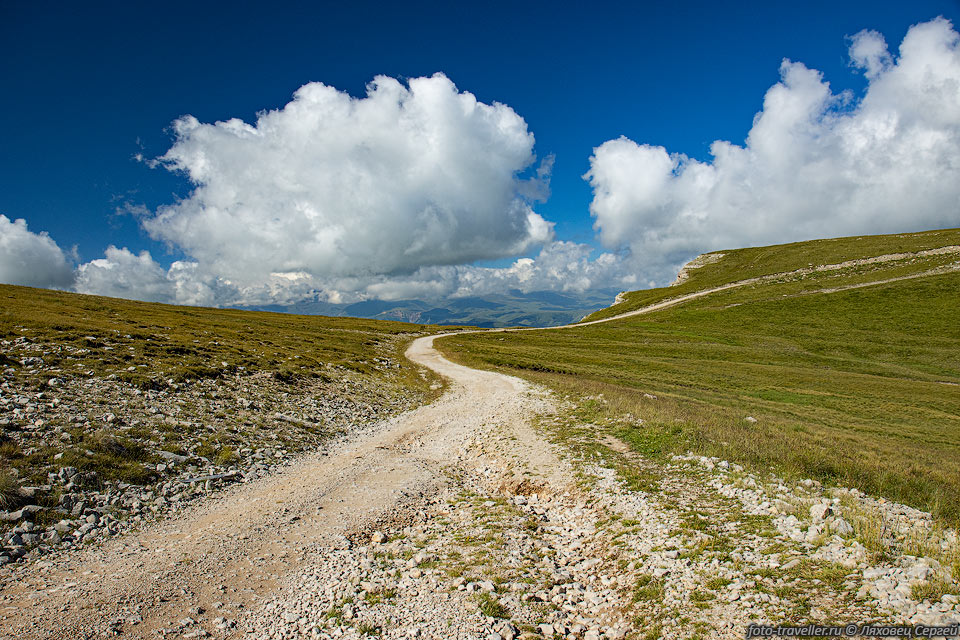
left=440, top=230, right=960, bottom=521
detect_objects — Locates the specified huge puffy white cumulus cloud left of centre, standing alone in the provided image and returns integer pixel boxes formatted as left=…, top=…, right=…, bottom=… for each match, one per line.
left=143, top=74, right=552, bottom=288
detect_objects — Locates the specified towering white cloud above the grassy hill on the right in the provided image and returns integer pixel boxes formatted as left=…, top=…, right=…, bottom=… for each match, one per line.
left=585, top=19, right=960, bottom=278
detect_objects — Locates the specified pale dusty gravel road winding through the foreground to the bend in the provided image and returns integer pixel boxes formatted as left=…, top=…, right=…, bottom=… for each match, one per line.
left=0, top=337, right=557, bottom=638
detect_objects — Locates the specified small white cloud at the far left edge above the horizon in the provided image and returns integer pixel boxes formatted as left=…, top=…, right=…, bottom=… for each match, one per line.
left=0, top=215, right=73, bottom=289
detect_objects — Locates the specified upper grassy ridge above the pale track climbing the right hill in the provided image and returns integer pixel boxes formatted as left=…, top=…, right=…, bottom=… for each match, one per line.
left=584, top=229, right=960, bottom=320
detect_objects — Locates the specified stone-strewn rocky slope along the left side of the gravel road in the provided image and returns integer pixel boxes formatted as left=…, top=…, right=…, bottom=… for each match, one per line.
left=0, top=338, right=423, bottom=565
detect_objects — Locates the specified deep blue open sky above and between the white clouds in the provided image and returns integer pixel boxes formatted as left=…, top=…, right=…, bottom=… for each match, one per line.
left=0, top=1, right=960, bottom=304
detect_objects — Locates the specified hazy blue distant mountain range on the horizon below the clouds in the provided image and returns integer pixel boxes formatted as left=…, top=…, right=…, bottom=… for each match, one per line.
left=243, top=289, right=619, bottom=327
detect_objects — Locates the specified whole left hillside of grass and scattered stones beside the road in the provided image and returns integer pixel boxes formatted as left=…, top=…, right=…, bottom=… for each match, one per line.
left=0, top=285, right=452, bottom=496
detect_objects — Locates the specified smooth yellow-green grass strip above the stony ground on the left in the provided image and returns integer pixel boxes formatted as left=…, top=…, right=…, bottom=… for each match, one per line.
left=0, top=285, right=450, bottom=389
